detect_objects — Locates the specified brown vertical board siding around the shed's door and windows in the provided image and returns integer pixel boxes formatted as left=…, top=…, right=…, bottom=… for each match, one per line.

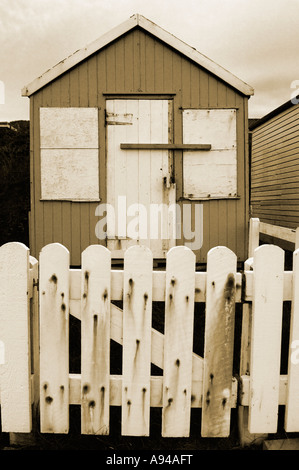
left=30, top=29, right=249, bottom=265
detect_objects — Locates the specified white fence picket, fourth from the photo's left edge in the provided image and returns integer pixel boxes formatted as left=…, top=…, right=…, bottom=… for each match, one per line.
left=122, top=246, right=153, bottom=436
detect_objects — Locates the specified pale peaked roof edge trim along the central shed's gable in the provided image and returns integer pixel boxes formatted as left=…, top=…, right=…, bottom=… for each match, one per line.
left=22, top=14, right=254, bottom=96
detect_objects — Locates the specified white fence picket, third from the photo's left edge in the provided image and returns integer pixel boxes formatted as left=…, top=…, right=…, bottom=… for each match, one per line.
left=81, top=245, right=111, bottom=434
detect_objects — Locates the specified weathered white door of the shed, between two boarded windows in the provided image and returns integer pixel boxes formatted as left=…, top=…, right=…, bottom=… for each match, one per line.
left=106, top=99, right=176, bottom=258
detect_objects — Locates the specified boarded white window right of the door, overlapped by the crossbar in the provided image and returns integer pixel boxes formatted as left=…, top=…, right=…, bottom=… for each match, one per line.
left=183, top=109, right=237, bottom=198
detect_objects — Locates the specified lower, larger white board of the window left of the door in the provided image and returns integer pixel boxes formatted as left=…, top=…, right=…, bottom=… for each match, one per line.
left=41, top=149, right=99, bottom=200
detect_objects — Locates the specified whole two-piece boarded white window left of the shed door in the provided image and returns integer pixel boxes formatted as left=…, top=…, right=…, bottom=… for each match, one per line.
left=40, top=108, right=99, bottom=201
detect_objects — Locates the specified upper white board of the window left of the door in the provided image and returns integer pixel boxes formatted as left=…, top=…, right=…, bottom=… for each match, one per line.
left=40, top=108, right=98, bottom=149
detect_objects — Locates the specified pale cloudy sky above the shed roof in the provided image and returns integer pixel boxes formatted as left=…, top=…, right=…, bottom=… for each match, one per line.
left=0, top=0, right=299, bottom=121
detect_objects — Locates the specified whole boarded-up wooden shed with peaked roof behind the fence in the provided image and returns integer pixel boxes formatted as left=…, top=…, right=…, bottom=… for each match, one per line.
left=22, top=14, right=253, bottom=266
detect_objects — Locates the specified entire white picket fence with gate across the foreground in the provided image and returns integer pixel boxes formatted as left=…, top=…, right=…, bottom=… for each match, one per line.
left=0, top=242, right=299, bottom=437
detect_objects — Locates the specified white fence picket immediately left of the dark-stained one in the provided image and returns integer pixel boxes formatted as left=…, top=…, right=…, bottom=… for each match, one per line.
left=162, top=246, right=195, bottom=437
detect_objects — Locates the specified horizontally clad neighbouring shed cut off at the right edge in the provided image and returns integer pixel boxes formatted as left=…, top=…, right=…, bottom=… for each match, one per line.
left=250, top=98, right=299, bottom=248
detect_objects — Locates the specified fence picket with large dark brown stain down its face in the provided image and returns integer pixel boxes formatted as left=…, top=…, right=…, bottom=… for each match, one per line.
left=201, top=246, right=237, bottom=437
